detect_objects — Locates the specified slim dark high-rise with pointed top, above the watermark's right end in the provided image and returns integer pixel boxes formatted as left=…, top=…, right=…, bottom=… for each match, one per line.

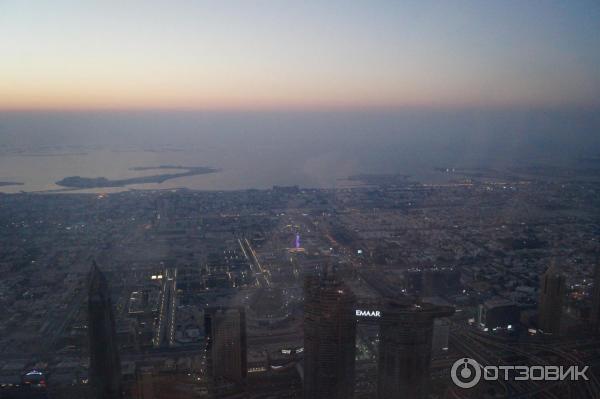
left=538, top=263, right=565, bottom=334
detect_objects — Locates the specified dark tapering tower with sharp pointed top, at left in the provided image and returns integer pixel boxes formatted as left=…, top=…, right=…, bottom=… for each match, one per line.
left=88, top=262, right=122, bottom=399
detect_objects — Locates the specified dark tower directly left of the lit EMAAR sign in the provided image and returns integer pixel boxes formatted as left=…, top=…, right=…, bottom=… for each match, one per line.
left=304, top=273, right=356, bottom=399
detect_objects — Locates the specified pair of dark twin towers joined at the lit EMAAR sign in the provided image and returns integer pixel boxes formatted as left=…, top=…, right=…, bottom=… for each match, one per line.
left=304, top=268, right=454, bottom=399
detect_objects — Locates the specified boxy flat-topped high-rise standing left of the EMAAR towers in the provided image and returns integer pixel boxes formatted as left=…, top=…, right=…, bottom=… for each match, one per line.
left=204, top=307, right=247, bottom=384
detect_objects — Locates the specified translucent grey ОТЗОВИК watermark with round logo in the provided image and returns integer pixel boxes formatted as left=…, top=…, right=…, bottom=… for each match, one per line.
left=450, top=357, right=589, bottom=389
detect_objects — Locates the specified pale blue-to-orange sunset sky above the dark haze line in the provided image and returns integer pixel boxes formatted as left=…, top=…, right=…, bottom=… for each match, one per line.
left=0, top=0, right=600, bottom=109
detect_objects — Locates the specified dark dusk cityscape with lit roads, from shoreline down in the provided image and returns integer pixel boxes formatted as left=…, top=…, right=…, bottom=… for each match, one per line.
left=0, top=168, right=600, bottom=399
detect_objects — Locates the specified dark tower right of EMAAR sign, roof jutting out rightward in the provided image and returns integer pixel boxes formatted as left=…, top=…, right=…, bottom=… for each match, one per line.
left=377, top=300, right=454, bottom=399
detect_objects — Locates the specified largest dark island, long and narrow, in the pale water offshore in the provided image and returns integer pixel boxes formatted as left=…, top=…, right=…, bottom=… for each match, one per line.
left=56, top=165, right=219, bottom=188
